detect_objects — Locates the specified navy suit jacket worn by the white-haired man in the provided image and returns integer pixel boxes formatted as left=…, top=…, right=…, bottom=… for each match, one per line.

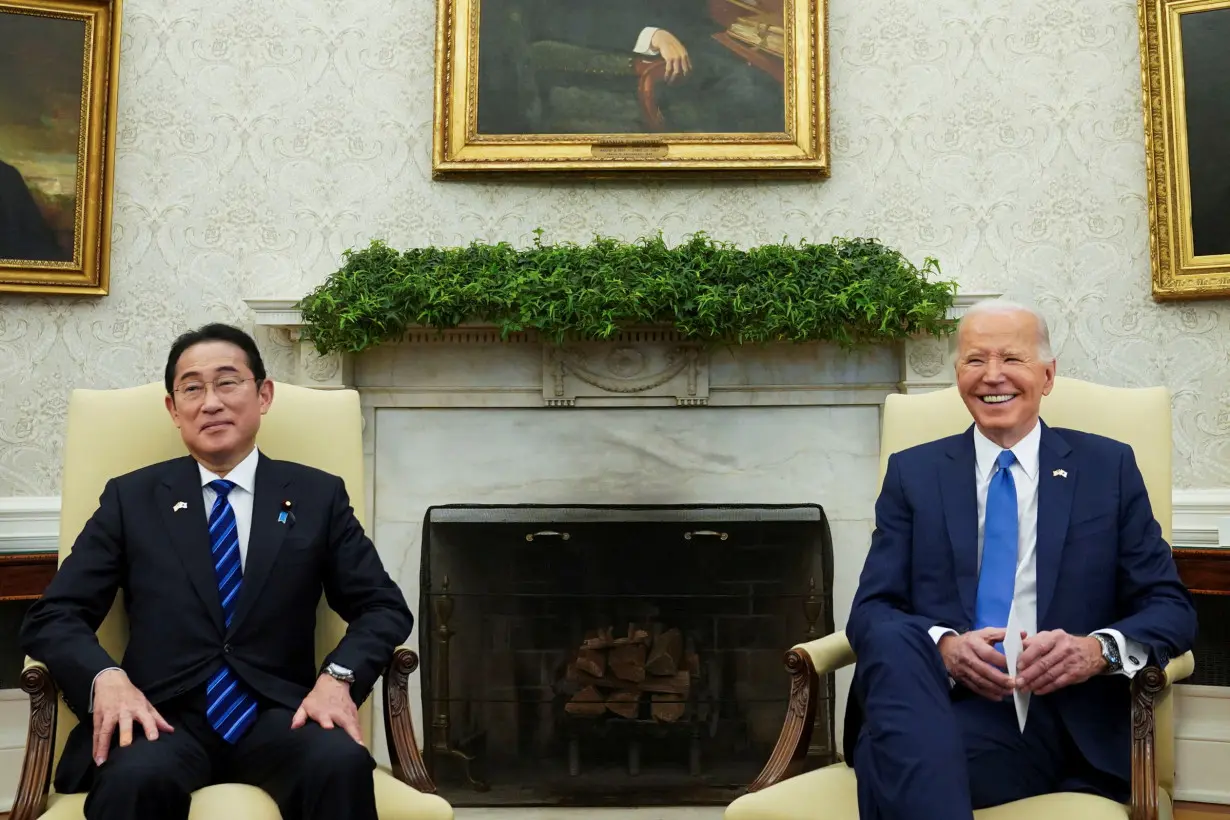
left=844, top=423, right=1196, bottom=782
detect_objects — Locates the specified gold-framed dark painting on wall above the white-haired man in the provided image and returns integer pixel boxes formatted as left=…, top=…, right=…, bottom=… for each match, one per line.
left=1140, top=0, right=1230, bottom=300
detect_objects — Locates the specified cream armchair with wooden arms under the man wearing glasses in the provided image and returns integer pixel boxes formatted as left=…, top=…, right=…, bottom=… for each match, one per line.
left=10, top=384, right=453, bottom=820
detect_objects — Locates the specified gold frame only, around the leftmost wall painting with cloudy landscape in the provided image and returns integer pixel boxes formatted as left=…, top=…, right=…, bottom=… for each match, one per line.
left=0, top=0, right=123, bottom=296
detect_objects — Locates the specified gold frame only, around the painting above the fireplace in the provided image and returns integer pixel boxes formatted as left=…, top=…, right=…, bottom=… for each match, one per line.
left=432, top=0, right=830, bottom=179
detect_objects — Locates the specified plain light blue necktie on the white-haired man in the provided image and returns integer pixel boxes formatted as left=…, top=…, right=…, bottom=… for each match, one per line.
left=974, top=450, right=1020, bottom=652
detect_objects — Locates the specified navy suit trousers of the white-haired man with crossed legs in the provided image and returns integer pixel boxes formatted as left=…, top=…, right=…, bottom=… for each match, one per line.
left=854, top=621, right=1125, bottom=820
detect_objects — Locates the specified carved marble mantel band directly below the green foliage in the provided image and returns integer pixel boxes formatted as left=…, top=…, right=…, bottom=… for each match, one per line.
left=246, top=293, right=998, bottom=408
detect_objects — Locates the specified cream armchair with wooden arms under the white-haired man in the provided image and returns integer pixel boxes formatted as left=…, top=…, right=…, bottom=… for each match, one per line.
left=726, top=379, right=1194, bottom=820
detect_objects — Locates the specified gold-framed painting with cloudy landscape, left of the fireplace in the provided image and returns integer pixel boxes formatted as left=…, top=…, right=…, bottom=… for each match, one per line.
left=0, top=0, right=121, bottom=295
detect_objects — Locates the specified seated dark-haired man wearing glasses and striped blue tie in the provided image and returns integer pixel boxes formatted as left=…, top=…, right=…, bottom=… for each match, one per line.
left=21, top=325, right=413, bottom=820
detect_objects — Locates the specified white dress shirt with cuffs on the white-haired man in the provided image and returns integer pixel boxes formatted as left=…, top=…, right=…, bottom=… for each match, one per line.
left=930, top=422, right=1148, bottom=698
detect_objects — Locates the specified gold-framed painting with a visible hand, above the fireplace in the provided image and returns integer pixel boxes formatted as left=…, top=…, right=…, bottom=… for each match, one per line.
left=432, top=0, right=829, bottom=178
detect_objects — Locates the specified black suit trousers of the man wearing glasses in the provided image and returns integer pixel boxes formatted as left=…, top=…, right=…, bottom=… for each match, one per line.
left=85, top=692, right=376, bottom=820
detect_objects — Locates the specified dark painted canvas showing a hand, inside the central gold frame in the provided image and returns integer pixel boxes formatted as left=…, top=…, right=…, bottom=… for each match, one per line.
left=478, top=0, right=786, bottom=134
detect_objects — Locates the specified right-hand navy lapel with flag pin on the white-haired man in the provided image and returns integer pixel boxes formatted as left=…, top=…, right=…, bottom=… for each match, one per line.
left=1037, top=424, right=1077, bottom=629
